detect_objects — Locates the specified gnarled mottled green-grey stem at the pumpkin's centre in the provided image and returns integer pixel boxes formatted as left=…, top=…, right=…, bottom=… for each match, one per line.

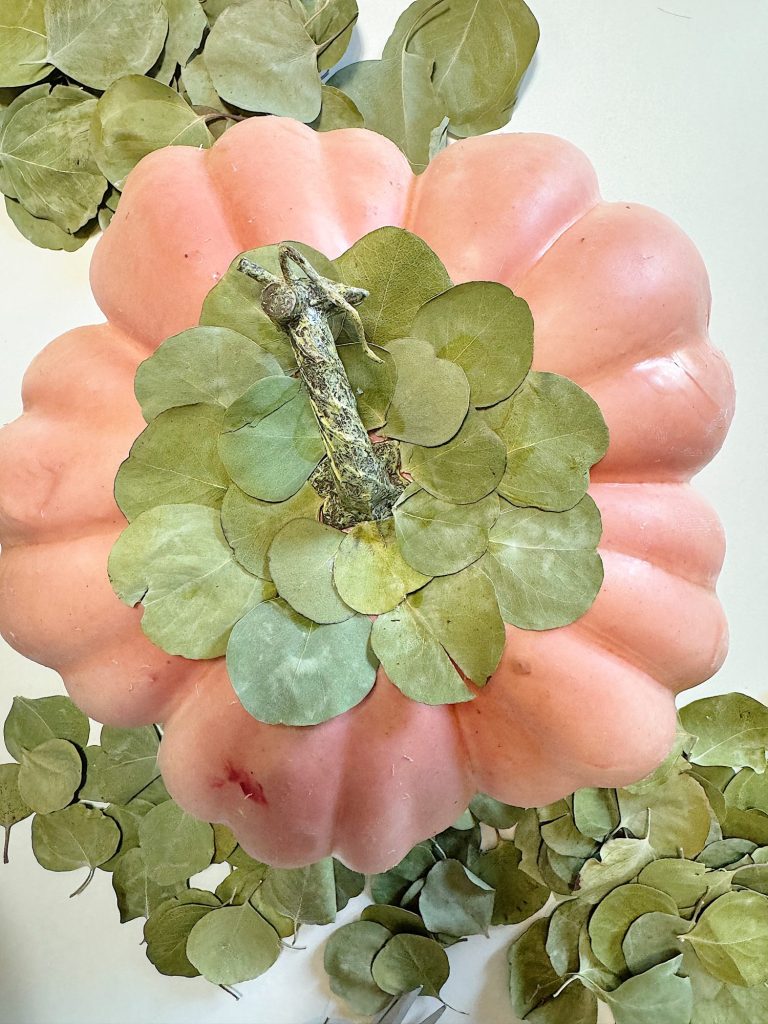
left=238, top=244, right=406, bottom=529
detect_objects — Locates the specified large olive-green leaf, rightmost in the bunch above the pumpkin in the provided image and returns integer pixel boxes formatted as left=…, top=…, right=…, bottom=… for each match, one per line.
left=384, top=0, right=539, bottom=136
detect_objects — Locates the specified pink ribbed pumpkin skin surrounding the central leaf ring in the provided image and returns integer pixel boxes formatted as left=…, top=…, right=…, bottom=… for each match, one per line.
left=0, top=118, right=733, bottom=871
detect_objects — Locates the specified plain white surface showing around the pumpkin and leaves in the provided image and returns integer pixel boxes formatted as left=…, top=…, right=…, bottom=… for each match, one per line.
left=0, top=0, right=768, bottom=1024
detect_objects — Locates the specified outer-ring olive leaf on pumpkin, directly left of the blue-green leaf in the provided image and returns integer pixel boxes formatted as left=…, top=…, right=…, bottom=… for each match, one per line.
left=115, top=405, right=230, bottom=522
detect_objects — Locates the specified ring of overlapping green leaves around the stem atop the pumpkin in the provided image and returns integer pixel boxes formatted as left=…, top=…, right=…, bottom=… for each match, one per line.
left=109, top=227, right=607, bottom=726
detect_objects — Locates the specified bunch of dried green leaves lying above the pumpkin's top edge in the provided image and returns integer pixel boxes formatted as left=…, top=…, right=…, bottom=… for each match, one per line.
left=0, top=0, right=538, bottom=252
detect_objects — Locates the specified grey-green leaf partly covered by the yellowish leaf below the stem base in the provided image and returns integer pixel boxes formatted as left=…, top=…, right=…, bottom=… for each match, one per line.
left=269, top=519, right=354, bottom=623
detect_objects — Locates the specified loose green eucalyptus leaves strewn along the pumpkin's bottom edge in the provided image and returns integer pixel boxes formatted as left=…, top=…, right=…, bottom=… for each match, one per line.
left=0, top=693, right=768, bottom=1024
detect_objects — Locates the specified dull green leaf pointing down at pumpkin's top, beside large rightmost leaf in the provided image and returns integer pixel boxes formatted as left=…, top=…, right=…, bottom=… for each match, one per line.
left=329, top=50, right=443, bottom=174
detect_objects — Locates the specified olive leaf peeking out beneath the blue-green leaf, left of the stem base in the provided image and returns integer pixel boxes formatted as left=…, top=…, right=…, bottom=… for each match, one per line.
left=221, top=483, right=323, bottom=580
